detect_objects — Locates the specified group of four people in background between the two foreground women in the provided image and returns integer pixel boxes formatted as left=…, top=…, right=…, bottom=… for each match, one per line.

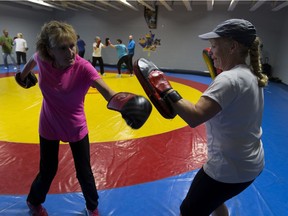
left=77, top=35, right=135, bottom=77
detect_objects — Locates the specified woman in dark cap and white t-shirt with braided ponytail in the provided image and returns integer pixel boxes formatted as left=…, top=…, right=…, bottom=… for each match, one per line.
left=170, top=19, right=268, bottom=216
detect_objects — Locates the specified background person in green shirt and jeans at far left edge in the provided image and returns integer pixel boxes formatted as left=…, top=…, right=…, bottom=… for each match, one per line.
left=0, top=29, right=17, bottom=70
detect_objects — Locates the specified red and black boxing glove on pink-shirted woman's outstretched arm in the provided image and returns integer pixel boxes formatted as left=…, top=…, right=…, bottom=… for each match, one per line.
left=107, top=92, right=152, bottom=129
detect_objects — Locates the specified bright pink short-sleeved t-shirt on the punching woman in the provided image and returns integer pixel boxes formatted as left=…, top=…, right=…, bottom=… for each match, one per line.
left=34, top=53, right=100, bottom=142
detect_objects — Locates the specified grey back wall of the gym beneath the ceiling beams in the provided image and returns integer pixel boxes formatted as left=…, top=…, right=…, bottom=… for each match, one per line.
left=0, top=3, right=288, bottom=83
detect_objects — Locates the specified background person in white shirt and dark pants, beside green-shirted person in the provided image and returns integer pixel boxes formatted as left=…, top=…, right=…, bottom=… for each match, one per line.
left=14, top=33, right=28, bottom=70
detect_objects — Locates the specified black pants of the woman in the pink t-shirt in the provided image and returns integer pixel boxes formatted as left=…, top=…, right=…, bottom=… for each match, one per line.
left=27, top=135, right=99, bottom=210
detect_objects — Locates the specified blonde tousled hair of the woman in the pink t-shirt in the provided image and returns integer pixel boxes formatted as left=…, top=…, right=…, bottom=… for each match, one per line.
left=36, top=20, right=77, bottom=61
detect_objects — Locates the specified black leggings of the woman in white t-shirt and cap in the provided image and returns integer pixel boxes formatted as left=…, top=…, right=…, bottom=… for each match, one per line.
left=180, top=168, right=254, bottom=216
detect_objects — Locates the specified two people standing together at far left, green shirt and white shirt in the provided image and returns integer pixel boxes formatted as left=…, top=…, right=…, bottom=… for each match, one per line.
left=0, top=29, right=28, bottom=70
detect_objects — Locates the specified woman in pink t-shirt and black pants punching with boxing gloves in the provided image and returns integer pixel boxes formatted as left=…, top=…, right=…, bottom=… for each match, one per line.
left=15, top=21, right=152, bottom=216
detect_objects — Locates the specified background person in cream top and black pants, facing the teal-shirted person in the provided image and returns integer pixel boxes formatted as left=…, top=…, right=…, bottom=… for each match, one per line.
left=92, top=36, right=106, bottom=76
